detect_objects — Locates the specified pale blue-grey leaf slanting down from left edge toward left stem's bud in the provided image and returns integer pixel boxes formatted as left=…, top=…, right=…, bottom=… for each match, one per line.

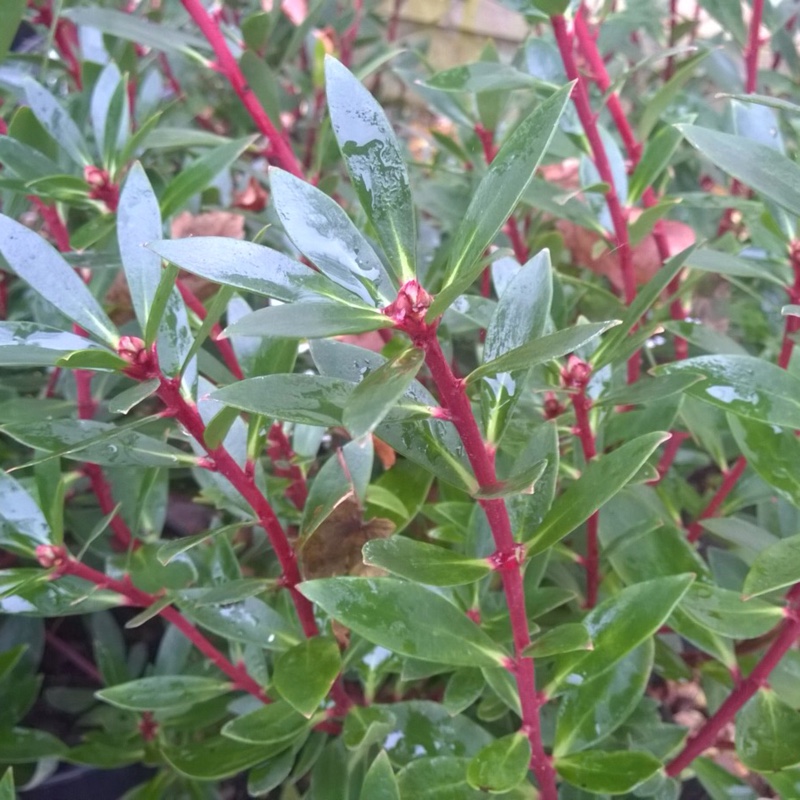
left=0, top=214, right=119, bottom=346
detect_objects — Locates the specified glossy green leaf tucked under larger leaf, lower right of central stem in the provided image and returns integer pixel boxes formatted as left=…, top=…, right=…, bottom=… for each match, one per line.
left=553, top=639, right=655, bottom=758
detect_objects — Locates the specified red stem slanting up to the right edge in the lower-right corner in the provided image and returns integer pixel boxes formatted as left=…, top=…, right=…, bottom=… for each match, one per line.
left=666, top=584, right=800, bottom=777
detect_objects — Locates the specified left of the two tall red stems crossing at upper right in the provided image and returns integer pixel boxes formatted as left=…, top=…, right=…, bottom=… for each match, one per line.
left=550, top=14, right=641, bottom=383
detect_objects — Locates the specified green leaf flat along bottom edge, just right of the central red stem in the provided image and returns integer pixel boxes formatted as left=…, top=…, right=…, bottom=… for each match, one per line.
left=555, top=750, right=661, bottom=794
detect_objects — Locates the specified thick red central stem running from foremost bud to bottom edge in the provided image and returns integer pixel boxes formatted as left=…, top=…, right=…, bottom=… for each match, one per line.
left=424, top=334, right=558, bottom=800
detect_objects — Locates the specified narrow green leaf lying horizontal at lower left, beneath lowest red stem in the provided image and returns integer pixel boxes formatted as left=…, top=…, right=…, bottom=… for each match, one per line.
left=95, top=675, right=233, bottom=711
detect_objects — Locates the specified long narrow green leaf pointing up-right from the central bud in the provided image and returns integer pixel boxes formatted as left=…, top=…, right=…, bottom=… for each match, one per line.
left=428, top=84, right=572, bottom=319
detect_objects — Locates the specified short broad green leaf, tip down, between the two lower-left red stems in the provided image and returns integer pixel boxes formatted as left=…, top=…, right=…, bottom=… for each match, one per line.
left=272, top=636, right=342, bottom=717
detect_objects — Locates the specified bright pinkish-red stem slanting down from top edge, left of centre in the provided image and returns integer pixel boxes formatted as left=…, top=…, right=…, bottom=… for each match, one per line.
left=181, top=0, right=303, bottom=178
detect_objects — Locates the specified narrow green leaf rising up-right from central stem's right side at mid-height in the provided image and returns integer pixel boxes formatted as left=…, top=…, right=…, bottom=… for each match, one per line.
left=527, top=431, right=669, bottom=555
